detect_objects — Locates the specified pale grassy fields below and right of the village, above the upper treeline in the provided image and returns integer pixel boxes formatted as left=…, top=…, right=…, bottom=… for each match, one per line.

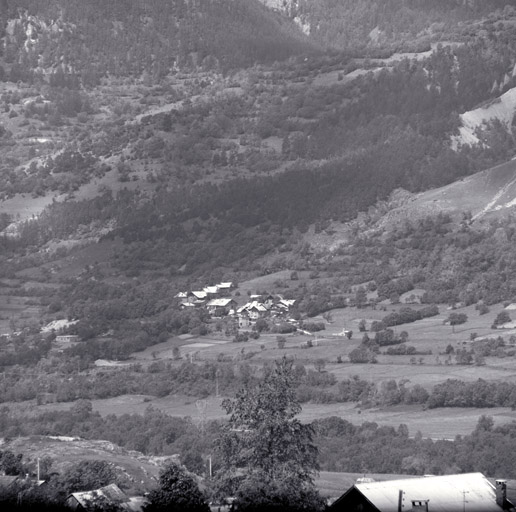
left=133, top=298, right=516, bottom=388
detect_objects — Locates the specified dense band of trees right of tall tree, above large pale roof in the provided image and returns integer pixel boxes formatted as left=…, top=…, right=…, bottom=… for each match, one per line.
left=313, top=416, right=516, bottom=478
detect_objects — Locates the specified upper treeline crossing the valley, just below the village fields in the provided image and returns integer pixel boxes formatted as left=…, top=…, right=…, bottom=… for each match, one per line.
left=4, top=352, right=516, bottom=408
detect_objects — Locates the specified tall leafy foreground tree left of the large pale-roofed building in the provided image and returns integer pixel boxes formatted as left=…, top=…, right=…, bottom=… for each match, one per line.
left=215, top=357, right=324, bottom=512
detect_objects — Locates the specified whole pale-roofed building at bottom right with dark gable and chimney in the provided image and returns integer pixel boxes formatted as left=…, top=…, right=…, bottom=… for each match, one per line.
left=330, top=473, right=516, bottom=512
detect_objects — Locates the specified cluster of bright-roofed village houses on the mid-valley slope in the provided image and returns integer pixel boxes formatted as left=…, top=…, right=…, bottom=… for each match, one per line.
left=175, top=282, right=296, bottom=329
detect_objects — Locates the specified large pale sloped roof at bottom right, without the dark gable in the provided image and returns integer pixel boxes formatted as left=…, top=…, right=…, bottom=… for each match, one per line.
left=334, top=473, right=508, bottom=512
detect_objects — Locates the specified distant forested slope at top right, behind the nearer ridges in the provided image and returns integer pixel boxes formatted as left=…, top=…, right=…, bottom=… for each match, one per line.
left=261, top=0, right=515, bottom=51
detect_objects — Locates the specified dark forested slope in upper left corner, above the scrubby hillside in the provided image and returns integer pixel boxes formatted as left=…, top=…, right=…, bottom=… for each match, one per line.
left=0, top=0, right=309, bottom=77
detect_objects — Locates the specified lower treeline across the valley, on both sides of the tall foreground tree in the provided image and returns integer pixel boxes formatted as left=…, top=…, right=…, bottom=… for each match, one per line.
left=5, top=401, right=516, bottom=480
